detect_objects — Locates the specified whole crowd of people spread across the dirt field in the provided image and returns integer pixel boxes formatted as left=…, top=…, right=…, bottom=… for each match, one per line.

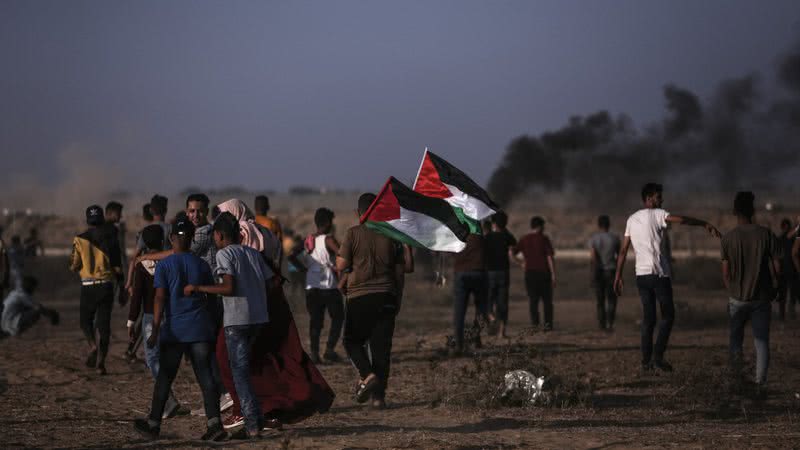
left=0, top=183, right=800, bottom=441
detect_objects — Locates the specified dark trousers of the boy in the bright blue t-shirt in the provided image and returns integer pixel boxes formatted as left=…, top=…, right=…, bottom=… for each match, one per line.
left=150, top=342, right=219, bottom=423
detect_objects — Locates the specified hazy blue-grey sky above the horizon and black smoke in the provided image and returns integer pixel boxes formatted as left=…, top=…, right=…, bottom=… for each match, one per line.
left=0, top=0, right=800, bottom=191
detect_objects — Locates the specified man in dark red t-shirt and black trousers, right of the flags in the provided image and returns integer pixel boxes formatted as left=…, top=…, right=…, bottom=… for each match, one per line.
left=509, top=216, right=556, bottom=331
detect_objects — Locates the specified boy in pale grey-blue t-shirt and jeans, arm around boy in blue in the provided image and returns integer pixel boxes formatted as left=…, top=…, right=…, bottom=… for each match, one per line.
left=184, top=212, right=272, bottom=438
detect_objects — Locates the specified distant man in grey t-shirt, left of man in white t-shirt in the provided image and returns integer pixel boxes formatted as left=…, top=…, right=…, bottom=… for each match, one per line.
left=589, top=216, right=620, bottom=331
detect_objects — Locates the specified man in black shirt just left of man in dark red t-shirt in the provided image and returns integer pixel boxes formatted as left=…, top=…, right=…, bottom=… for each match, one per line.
left=485, top=211, right=517, bottom=337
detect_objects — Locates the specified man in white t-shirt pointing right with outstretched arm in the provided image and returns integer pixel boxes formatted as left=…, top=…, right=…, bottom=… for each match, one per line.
left=614, top=183, right=721, bottom=372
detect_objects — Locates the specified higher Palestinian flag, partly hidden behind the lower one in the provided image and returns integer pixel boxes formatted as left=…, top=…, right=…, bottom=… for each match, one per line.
left=414, top=148, right=500, bottom=225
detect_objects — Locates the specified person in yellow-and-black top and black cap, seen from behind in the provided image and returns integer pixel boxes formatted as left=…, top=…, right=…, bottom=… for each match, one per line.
left=69, top=205, right=122, bottom=375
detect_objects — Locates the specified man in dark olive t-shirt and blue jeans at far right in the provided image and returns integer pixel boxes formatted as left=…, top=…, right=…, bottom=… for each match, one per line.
left=722, top=192, right=782, bottom=396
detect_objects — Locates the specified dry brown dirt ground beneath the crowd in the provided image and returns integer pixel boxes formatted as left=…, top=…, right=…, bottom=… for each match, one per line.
left=0, top=257, right=800, bottom=449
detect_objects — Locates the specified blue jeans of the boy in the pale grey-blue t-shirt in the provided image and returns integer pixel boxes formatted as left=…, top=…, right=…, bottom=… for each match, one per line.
left=225, top=324, right=263, bottom=432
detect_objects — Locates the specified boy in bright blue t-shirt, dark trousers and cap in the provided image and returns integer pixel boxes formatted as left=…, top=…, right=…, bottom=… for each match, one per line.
left=134, top=219, right=227, bottom=441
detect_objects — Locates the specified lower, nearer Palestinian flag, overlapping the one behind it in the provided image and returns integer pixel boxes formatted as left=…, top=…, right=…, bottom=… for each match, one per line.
left=361, top=177, right=469, bottom=253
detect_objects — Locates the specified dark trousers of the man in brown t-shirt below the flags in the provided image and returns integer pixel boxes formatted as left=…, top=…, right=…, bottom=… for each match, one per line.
left=344, top=292, right=397, bottom=398
